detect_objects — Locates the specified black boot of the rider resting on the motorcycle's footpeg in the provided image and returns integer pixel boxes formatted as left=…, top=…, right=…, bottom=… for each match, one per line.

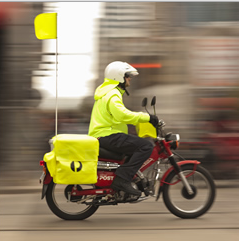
left=110, top=176, right=141, bottom=196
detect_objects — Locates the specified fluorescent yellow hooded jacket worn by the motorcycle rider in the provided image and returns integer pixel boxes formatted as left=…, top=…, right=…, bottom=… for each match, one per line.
left=88, top=79, right=150, bottom=138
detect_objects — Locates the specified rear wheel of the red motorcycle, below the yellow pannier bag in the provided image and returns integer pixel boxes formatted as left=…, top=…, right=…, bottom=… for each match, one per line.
left=46, top=182, right=99, bottom=220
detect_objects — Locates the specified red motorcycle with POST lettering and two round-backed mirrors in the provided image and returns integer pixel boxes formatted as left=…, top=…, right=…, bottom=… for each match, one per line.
left=40, top=97, right=216, bottom=220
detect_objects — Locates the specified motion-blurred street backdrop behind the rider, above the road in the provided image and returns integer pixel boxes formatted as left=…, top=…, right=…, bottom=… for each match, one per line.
left=0, top=2, right=239, bottom=179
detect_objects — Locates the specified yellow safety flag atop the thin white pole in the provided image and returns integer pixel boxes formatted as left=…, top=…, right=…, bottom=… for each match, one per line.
left=34, top=13, right=57, bottom=39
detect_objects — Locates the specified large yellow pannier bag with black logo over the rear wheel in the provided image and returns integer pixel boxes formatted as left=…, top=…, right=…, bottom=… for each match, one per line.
left=43, top=134, right=99, bottom=184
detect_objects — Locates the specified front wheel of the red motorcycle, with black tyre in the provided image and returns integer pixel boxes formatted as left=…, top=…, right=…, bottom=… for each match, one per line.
left=163, top=164, right=216, bottom=218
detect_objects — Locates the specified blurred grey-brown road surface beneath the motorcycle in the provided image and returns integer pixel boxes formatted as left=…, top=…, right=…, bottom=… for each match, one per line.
left=0, top=171, right=239, bottom=241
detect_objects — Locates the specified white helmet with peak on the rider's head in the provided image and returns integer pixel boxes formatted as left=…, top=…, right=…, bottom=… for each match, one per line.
left=105, top=61, right=139, bottom=83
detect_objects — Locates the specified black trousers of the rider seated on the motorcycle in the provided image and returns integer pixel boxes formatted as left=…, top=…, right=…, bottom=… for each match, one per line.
left=99, top=133, right=153, bottom=181
